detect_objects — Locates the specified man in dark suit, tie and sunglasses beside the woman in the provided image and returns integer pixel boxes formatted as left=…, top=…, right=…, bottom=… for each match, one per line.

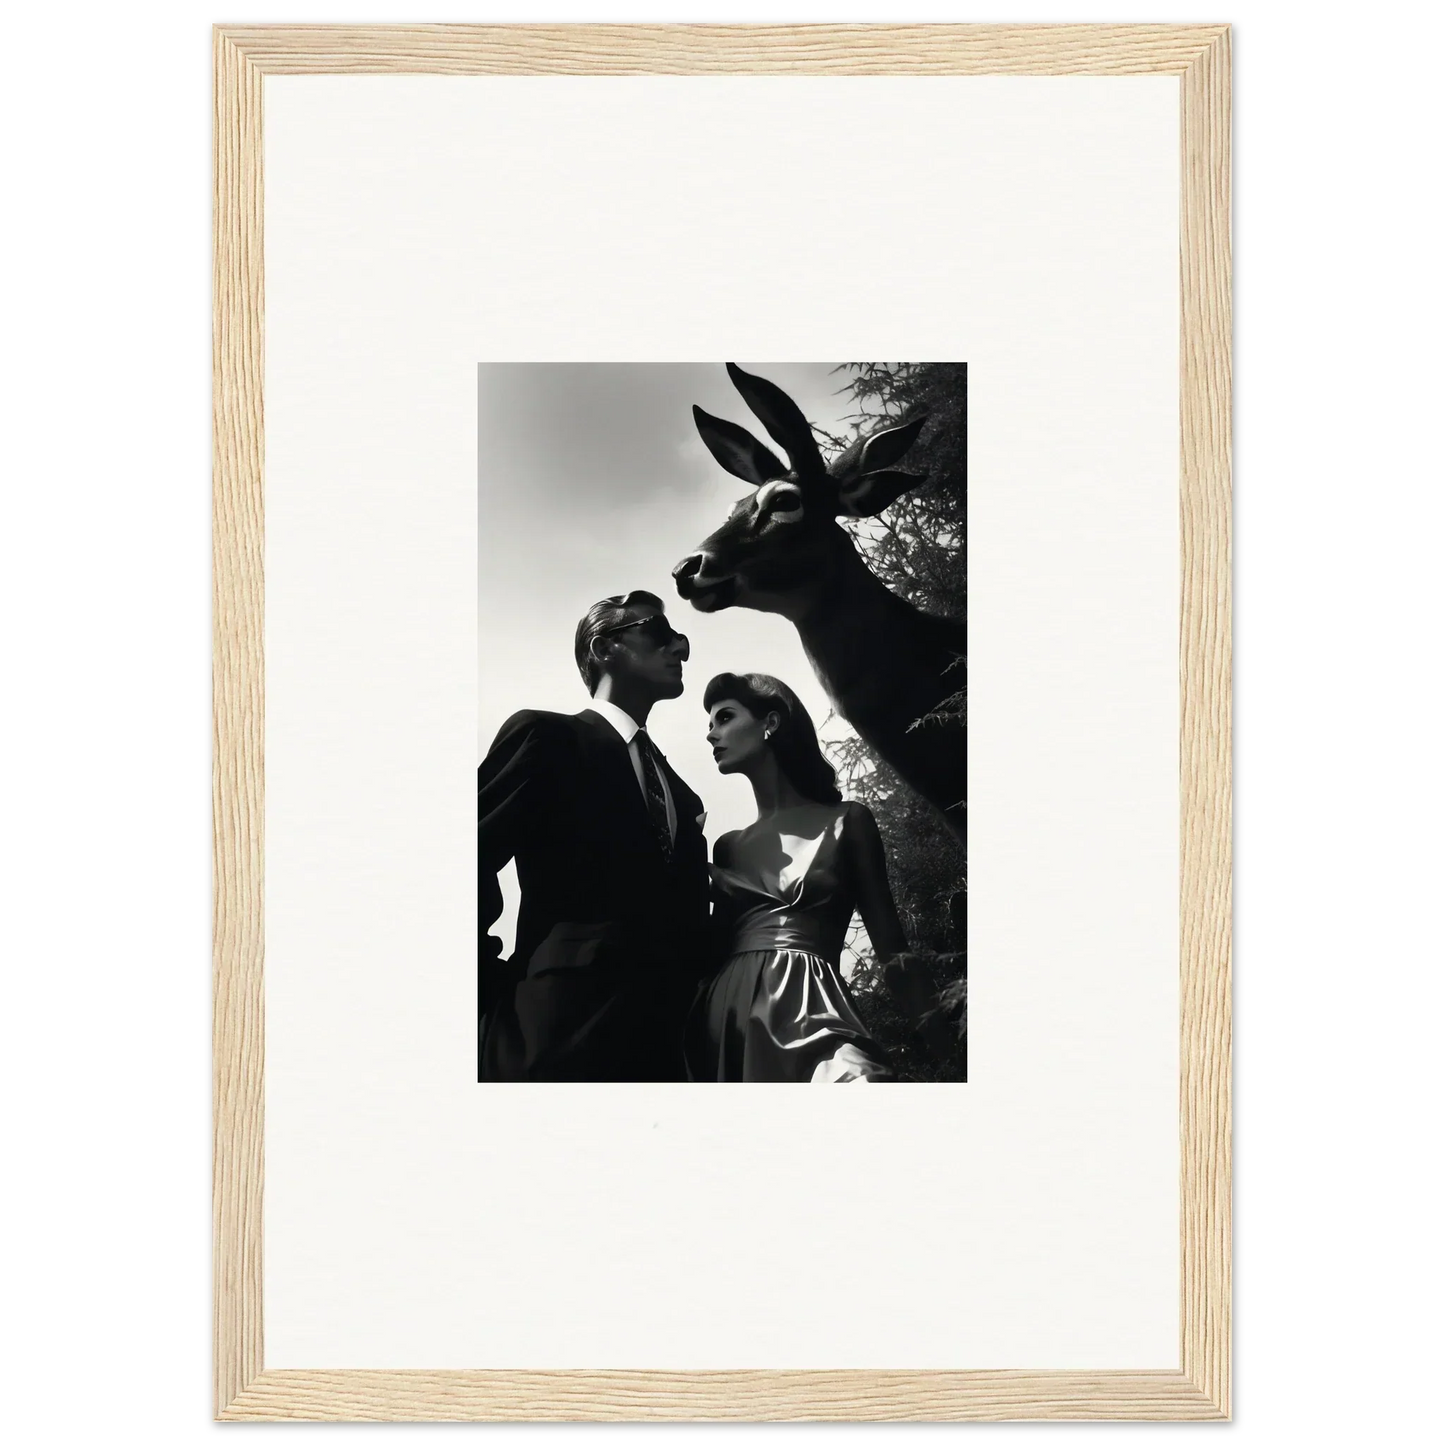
left=477, top=592, right=708, bottom=1081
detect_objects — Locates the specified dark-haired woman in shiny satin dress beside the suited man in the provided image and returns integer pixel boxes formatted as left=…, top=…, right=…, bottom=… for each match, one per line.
left=686, top=672, right=951, bottom=1084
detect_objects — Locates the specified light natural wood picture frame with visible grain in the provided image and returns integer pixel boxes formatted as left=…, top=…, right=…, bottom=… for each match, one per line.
left=210, top=20, right=1235, bottom=1433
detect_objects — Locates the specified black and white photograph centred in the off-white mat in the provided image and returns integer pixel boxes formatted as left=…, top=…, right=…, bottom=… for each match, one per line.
left=477, top=361, right=968, bottom=1084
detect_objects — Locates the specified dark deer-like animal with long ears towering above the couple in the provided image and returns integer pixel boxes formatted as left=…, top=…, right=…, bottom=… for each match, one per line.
left=672, top=363, right=968, bottom=838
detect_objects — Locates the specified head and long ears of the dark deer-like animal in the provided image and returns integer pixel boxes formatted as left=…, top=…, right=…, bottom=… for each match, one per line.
left=672, top=363, right=928, bottom=614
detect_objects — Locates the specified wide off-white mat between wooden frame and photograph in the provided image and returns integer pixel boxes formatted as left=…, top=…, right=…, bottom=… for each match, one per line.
left=264, top=77, right=1178, bottom=1368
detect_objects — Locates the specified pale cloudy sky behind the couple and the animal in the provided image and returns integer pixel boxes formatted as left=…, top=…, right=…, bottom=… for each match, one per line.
left=477, top=360, right=851, bottom=948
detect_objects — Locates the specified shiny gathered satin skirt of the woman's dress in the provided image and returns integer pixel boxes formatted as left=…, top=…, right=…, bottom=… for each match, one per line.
left=686, top=948, right=894, bottom=1084
